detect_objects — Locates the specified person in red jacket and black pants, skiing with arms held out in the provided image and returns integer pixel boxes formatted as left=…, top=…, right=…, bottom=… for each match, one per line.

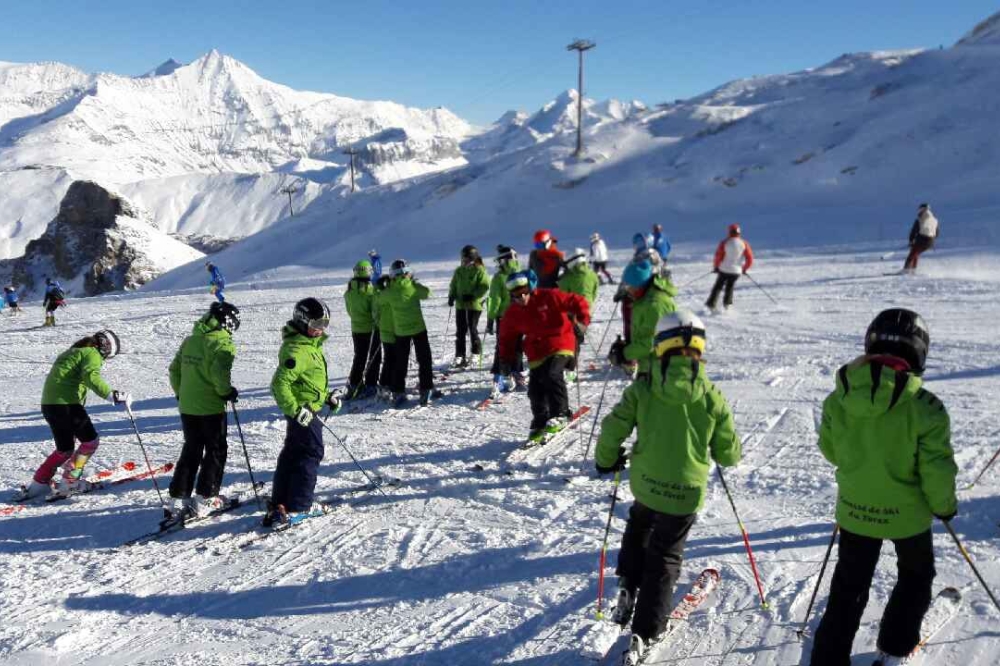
left=499, top=271, right=590, bottom=442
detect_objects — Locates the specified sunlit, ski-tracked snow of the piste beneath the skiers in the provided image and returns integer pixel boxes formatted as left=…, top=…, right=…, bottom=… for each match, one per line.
left=0, top=251, right=1000, bottom=666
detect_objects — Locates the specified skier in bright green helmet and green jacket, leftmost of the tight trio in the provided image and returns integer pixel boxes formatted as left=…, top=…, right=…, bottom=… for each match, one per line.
left=344, top=259, right=382, bottom=400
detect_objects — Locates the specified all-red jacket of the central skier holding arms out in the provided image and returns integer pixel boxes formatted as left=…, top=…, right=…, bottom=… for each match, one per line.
left=500, top=289, right=590, bottom=365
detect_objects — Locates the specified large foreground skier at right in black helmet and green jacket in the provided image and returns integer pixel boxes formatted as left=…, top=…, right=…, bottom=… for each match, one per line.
left=812, top=309, right=958, bottom=666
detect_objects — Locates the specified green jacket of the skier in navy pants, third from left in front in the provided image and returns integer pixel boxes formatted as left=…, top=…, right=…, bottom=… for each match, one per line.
left=271, top=325, right=330, bottom=418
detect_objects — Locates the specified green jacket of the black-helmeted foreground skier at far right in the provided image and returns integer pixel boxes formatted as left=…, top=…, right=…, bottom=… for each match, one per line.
left=819, top=357, right=958, bottom=539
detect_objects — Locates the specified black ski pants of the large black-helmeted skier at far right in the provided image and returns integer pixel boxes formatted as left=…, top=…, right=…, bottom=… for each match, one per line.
left=811, top=528, right=936, bottom=666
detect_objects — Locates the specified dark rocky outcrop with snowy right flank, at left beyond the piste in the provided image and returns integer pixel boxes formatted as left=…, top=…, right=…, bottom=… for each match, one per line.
left=0, top=180, right=203, bottom=296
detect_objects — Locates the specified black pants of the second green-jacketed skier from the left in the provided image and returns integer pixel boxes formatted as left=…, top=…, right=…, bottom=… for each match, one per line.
left=170, top=412, right=229, bottom=499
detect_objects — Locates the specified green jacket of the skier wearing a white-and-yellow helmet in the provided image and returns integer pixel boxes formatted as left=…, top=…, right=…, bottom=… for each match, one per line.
left=595, top=356, right=741, bottom=516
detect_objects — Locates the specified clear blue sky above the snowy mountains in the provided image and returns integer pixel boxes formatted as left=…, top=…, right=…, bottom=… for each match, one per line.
left=0, top=0, right=1000, bottom=124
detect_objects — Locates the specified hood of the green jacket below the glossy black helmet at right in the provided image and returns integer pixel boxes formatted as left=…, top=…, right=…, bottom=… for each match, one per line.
left=837, top=356, right=923, bottom=417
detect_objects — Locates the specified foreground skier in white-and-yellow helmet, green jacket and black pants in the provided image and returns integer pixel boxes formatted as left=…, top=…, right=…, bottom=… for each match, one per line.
left=595, top=310, right=741, bottom=665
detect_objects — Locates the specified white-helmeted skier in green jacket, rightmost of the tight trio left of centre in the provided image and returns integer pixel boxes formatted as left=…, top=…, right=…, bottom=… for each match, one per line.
left=385, top=259, right=441, bottom=409
